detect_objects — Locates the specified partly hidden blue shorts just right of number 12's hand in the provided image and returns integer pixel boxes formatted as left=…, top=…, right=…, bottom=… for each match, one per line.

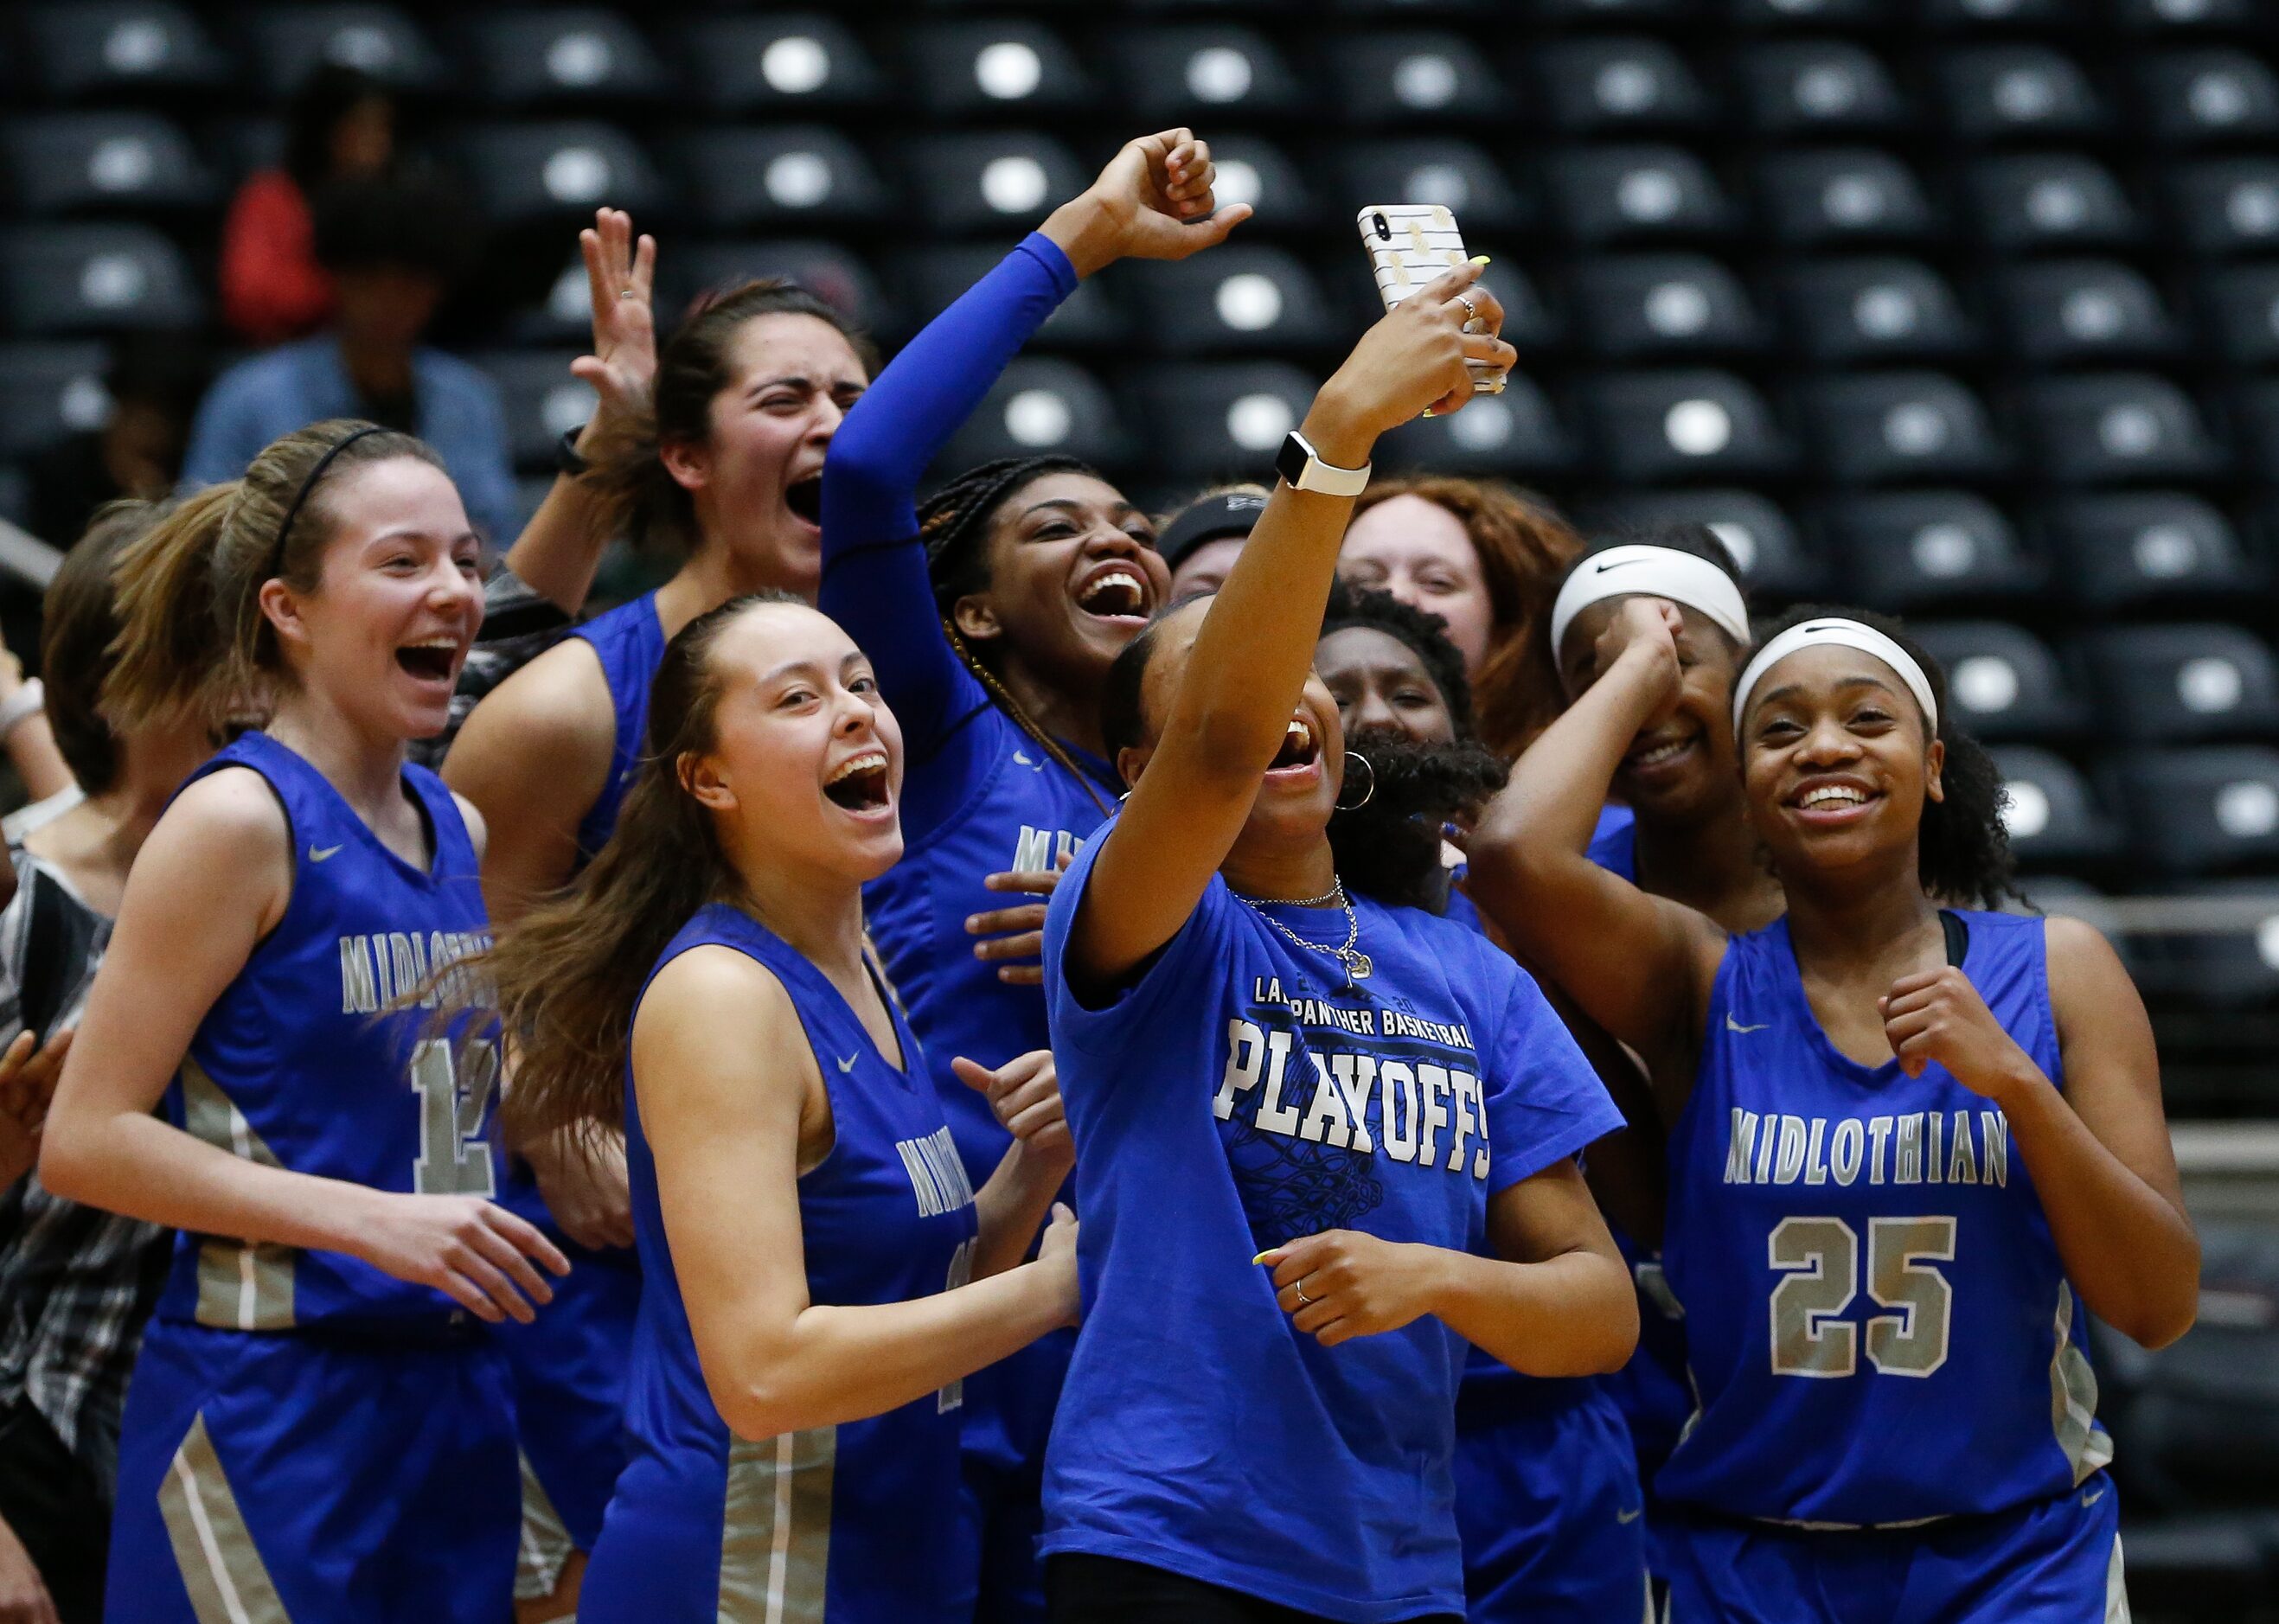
left=496, top=1223, right=640, bottom=1596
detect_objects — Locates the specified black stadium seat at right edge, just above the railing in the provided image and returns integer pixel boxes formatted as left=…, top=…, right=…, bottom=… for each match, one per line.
left=2099, top=745, right=2279, bottom=877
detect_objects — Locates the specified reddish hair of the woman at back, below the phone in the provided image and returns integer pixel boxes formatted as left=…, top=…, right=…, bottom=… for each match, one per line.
left=1354, top=474, right=1582, bottom=761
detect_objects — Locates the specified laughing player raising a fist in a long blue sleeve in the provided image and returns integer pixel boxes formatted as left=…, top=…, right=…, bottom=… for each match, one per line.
left=818, top=130, right=1249, bottom=1624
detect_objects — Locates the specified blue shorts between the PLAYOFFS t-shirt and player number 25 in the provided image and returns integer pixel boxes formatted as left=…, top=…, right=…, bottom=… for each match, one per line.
left=1456, top=1380, right=1648, bottom=1624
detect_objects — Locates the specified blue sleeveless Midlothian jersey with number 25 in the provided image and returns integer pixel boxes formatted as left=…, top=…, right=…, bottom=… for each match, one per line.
left=1657, top=913, right=2113, bottom=1524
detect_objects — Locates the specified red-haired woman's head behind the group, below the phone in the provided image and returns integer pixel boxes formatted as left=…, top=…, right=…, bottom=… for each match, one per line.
left=1338, top=476, right=1582, bottom=761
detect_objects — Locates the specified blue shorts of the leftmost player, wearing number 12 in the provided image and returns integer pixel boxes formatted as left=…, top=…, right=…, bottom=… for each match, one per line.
left=105, top=1321, right=520, bottom=1624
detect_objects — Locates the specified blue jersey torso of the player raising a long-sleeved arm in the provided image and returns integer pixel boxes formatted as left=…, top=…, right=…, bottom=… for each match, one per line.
left=864, top=704, right=1121, bottom=1186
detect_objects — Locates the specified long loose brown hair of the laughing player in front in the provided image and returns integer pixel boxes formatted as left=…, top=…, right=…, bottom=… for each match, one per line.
left=440, top=592, right=800, bottom=1141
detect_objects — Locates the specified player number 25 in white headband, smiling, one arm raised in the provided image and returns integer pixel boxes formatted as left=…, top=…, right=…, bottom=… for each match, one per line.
left=1472, top=597, right=2199, bottom=1624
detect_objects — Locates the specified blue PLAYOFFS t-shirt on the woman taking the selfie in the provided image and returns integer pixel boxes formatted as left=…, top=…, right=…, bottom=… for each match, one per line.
left=1041, top=820, right=1623, bottom=1624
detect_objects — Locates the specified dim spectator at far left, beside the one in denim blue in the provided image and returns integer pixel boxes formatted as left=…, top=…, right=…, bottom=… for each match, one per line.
left=28, top=333, right=212, bottom=547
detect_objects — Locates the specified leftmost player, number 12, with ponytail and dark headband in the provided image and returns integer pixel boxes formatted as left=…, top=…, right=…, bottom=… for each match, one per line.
left=41, top=421, right=567, bottom=1624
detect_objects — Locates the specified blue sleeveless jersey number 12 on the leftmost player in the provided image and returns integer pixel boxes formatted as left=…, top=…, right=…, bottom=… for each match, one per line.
left=157, top=733, right=496, bottom=1330
